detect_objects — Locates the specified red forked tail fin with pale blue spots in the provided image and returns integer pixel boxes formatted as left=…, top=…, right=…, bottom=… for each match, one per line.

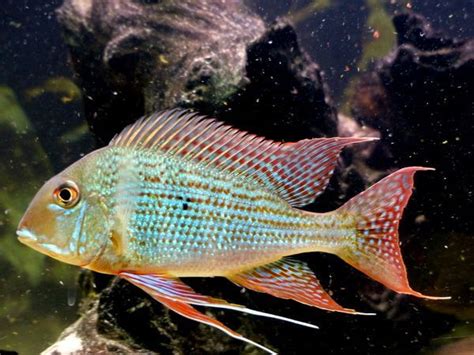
left=338, top=167, right=449, bottom=299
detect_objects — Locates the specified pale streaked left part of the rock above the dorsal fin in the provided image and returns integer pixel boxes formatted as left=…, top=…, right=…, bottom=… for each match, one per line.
left=58, top=0, right=264, bottom=143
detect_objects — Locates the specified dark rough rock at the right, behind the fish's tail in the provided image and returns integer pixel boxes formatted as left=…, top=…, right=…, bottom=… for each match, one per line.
left=352, top=14, right=474, bottom=316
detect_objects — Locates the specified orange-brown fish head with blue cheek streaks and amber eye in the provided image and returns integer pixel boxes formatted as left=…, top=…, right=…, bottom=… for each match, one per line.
left=16, top=157, right=110, bottom=266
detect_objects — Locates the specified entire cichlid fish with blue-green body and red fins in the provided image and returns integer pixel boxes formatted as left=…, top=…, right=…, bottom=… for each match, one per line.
left=17, top=110, right=441, bottom=353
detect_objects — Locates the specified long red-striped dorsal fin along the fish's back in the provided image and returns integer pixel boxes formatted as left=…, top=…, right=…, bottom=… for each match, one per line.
left=109, top=109, right=373, bottom=206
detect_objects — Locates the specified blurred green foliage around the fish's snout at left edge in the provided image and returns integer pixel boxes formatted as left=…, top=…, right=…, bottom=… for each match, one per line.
left=0, top=82, right=88, bottom=353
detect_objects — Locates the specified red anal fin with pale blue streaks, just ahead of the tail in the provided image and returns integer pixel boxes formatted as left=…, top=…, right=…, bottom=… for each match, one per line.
left=229, top=258, right=368, bottom=315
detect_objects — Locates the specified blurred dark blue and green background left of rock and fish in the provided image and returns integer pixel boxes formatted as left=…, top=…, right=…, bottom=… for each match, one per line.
left=0, top=6, right=94, bottom=354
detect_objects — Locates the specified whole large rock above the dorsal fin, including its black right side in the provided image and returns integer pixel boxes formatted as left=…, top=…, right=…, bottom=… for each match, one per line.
left=58, top=0, right=337, bottom=143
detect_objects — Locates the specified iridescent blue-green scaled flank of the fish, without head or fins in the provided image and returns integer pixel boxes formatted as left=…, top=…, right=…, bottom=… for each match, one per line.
left=93, top=147, right=355, bottom=276
